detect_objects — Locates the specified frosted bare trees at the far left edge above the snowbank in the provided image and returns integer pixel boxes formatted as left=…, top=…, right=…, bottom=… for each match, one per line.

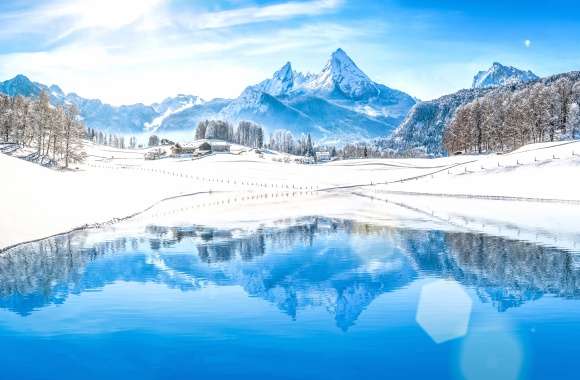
left=0, top=92, right=85, bottom=167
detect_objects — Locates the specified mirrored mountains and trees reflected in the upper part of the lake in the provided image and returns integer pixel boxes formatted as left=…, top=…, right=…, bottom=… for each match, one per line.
left=0, top=218, right=580, bottom=330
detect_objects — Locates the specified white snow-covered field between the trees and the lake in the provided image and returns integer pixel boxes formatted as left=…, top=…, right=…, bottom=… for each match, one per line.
left=0, top=142, right=580, bottom=249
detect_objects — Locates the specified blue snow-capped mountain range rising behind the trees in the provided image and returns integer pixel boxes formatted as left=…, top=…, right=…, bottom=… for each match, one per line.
left=0, top=53, right=538, bottom=152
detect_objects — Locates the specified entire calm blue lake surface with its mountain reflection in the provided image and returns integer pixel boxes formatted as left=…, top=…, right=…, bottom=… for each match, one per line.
left=0, top=217, right=580, bottom=380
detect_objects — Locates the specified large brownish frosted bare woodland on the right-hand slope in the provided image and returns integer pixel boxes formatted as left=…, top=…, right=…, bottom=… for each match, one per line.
left=443, top=76, right=580, bottom=153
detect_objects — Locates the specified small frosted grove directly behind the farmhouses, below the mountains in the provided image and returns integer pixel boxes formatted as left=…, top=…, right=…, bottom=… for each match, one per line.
left=195, top=120, right=264, bottom=148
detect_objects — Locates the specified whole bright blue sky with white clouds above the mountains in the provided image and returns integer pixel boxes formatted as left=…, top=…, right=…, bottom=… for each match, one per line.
left=0, top=0, right=580, bottom=104
